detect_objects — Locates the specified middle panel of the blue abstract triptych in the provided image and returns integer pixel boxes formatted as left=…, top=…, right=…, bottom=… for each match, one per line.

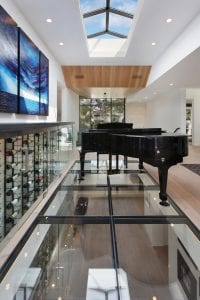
left=19, top=30, right=40, bottom=115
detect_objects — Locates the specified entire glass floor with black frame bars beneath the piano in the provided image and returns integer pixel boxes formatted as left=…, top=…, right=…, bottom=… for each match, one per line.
left=0, top=161, right=200, bottom=300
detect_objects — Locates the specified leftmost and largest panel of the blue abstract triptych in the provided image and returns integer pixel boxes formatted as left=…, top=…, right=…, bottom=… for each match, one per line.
left=0, top=6, right=18, bottom=113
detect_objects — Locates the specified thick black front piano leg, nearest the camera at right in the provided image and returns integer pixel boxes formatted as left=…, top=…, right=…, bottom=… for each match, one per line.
left=158, top=165, right=169, bottom=206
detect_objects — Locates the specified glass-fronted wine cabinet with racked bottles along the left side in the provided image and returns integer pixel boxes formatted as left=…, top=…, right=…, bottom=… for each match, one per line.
left=0, top=122, right=74, bottom=241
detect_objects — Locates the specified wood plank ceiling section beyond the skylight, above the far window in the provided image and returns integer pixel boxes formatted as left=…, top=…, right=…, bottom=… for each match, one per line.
left=62, top=66, right=151, bottom=97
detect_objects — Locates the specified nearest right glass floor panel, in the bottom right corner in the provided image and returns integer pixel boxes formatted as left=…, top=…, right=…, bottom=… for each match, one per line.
left=116, top=224, right=200, bottom=300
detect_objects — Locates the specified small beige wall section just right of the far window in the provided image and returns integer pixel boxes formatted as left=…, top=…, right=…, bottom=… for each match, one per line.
left=126, top=102, right=146, bottom=128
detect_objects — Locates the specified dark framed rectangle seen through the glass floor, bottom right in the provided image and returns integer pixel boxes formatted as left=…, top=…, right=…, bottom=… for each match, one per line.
left=177, top=250, right=197, bottom=300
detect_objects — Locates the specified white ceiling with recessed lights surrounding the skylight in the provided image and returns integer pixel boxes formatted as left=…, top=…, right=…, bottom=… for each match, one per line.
left=12, top=0, right=200, bottom=99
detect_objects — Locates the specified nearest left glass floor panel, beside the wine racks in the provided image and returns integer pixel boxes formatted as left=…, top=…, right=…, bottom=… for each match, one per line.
left=0, top=224, right=112, bottom=300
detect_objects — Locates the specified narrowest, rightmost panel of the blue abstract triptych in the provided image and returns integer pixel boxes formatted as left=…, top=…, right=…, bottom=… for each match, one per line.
left=40, top=52, right=49, bottom=116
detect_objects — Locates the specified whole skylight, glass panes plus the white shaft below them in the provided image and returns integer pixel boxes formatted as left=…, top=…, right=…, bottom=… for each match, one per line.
left=80, top=0, right=138, bottom=57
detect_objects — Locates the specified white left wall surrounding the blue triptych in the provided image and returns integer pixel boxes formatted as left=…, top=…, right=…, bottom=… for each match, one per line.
left=0, top=0, right=65, bottom=123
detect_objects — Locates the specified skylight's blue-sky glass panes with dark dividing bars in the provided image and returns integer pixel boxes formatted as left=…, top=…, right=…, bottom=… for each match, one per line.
left=80, top=0, right=138, bottom=39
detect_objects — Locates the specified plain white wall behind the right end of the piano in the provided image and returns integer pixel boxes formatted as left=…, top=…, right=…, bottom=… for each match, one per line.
left=146, top=89, right=186, bottom=133
